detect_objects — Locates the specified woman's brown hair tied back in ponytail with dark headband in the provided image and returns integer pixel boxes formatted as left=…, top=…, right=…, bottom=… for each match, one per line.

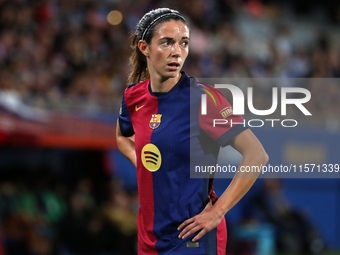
left=128, top=8, right=187, bottom=84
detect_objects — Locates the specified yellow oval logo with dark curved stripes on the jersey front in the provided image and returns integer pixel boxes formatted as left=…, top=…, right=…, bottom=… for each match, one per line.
left=141, top=143, right=162, bottom=172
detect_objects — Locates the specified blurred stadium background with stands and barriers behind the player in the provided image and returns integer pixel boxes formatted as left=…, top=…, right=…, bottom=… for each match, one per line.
left=0, top=0, right=340, bottom=255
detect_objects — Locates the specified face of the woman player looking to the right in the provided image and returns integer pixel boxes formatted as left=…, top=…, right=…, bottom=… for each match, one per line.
left=147, top=20, right=189, bottom=79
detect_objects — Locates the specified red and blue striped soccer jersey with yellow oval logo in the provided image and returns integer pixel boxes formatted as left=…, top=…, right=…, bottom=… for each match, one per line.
left=119, top=72, right=245, bottom=255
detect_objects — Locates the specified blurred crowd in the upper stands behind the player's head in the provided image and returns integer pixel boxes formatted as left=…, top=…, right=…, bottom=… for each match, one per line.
left=0, top=0, right=340, bottom=127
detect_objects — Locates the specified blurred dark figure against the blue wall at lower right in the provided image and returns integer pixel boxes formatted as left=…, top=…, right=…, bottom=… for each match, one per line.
left=228, top=178, right=327, bottom=255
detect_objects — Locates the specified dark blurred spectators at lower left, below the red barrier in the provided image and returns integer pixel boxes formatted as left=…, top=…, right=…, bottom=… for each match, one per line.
left=0, top=178, right=139, bottom=255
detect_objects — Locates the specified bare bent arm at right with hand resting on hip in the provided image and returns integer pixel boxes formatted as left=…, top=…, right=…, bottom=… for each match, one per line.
left=178, top=129, right=269, bottom=242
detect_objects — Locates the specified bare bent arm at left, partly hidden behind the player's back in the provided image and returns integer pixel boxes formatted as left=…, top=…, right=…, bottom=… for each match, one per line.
left=116, top=120, right=137, bottom=166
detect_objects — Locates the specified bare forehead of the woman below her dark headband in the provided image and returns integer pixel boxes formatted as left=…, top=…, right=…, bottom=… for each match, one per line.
left=154, top=20, right=189, bottom=39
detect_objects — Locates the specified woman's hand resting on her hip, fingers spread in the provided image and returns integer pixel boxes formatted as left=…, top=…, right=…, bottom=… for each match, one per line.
left=178, top=201, right=224, bottom=242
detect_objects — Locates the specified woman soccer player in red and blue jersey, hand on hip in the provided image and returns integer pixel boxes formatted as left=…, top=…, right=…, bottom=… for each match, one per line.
left=117, top=8, right=268, bottom=255
